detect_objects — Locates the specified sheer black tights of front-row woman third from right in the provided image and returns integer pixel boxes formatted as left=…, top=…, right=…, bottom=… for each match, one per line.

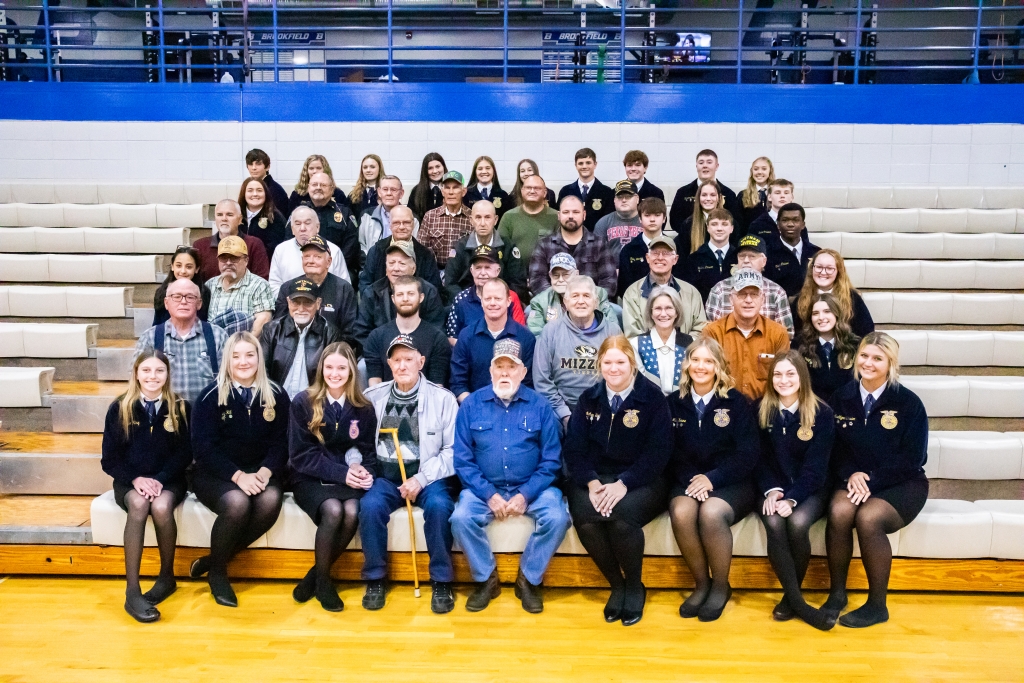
left=669, top=496, right=736, bottom=604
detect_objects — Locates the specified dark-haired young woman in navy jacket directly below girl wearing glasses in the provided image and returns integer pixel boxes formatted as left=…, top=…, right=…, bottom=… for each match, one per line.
left=799, top=294, right=860, bottom=400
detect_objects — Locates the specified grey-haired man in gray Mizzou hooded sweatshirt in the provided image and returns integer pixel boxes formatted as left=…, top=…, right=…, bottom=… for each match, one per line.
left=534, top=275, right=622, bottom=424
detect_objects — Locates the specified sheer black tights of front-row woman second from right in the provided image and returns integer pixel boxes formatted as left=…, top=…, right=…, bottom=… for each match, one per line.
left=761, top=494, right=825, bottom=609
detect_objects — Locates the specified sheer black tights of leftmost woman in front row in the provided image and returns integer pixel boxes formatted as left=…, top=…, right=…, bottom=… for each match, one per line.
left=124, top=489, right=178, bottom=594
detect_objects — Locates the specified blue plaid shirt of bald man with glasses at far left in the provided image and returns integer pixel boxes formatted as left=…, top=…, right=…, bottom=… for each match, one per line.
left=132, top=321, right=227, bottom=403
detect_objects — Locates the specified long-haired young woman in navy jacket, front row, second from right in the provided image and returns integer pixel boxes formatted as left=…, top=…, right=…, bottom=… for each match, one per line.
left=756, top=351, right=837, bottom=631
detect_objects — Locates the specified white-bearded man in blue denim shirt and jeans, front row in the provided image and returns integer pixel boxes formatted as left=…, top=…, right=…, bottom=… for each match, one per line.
left=452, top=338, right=570, bottom=613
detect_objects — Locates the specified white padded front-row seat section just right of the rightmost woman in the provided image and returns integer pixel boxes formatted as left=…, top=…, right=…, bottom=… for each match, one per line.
left=899, top=499, right=992, bottom=559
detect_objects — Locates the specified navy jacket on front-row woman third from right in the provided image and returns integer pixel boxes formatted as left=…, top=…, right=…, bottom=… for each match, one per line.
left=669, top=389, right=760, bottom=488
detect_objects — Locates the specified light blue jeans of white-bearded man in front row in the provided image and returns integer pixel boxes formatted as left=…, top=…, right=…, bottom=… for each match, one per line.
left=450, top=486, right=571, bottom=586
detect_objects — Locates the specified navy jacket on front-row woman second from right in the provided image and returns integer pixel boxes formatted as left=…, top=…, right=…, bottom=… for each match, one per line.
left=755, top=403, right=836, bottom=505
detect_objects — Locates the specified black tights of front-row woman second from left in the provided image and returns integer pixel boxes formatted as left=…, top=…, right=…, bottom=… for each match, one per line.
left=210, top=486, right=282, bottom=577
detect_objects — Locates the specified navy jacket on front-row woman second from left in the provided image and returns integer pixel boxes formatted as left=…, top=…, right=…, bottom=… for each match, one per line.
left=191, top=382, right=291, bottom=481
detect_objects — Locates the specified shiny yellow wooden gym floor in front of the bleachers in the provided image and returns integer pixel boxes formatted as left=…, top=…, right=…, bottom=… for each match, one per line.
left=0, top=577, right=1024, bottom=683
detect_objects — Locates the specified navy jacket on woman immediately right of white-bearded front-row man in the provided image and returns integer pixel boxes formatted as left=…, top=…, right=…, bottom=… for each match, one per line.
left=562, top=375, right=672, bottom=488
